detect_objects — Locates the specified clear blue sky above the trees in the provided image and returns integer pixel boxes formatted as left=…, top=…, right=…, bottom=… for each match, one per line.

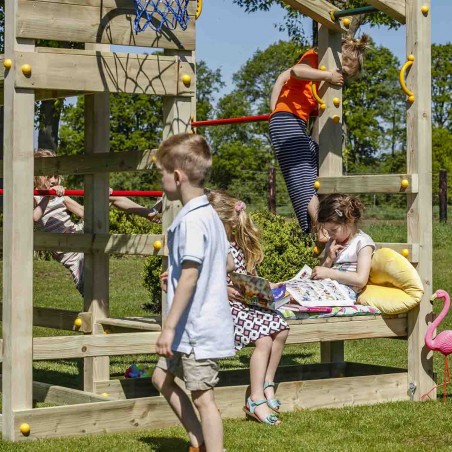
left=196, top=0, right=452, bottom=94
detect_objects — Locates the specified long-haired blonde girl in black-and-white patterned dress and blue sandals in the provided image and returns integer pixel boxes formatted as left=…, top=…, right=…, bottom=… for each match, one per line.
left=208, top=191, right=289, bottom=425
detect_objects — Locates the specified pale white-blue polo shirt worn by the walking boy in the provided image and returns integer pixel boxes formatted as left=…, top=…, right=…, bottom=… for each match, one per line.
left=168, top=195, right=235, bottom=359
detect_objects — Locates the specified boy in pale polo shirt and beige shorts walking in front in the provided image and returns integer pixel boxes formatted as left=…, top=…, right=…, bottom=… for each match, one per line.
left=152, top=134, right=234, bottom=452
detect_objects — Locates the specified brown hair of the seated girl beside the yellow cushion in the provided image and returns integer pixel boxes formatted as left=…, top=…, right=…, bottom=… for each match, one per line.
left=317, top=193, right=364, bottom=228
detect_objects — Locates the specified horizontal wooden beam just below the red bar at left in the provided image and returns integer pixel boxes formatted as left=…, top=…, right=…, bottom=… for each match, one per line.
left=0, top=232, right=165, bottom=256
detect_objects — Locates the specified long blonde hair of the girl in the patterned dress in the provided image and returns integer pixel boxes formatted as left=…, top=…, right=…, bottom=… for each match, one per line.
left=207, top=191, right=264, bottom=273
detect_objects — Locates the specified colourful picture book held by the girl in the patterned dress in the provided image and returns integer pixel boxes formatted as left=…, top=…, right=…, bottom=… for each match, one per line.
left=229, top=272, right=290, bottom=310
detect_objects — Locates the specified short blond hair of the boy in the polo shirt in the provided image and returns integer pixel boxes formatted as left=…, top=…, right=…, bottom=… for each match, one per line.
left=156, top=133, right=212, bottom=187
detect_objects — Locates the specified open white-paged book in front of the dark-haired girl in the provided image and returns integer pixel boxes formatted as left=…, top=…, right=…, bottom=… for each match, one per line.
left=285, top=265, right=355, bottom=306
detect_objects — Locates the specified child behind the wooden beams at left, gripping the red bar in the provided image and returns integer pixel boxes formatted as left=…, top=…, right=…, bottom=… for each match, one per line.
left=33, top=149, right=161, bottom=296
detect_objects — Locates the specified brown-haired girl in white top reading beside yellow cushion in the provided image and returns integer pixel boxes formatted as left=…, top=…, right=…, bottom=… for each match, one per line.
left=311, top=193, right=375, bottom=299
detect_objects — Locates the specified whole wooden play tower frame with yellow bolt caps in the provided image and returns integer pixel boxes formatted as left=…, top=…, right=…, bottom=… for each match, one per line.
left=1, top=0, right=434, bottom=441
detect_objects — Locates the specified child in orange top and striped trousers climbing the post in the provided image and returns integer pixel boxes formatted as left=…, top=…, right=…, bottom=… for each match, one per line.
left=269, top=35, right=368, bottom=235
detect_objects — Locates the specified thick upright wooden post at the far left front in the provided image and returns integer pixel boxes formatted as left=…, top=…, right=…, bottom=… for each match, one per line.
left=2, top=0, right=35, bottom=440
